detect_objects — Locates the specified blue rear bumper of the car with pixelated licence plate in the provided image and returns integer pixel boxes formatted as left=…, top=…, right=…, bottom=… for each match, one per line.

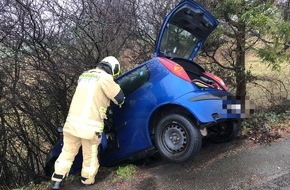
left=176, top=91, right=254, bottom=123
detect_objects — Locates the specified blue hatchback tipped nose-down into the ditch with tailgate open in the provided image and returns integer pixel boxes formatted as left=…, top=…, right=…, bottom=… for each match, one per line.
left=46, top=0, right=247, bottom=175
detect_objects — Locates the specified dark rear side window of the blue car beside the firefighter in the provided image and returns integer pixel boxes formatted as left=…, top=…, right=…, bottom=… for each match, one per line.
left=117, top=65, right=150, bottom=96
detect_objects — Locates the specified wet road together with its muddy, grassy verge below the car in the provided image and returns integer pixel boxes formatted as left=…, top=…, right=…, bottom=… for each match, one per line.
left=59, top=137, right=290, bottom=190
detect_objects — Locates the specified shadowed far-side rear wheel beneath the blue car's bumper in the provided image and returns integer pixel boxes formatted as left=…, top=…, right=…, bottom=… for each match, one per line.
left=209, top=120, right=239, bottom=143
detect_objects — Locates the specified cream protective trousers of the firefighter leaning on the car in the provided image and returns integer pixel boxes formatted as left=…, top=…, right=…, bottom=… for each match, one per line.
left=51, top=132, right=101, bottom=184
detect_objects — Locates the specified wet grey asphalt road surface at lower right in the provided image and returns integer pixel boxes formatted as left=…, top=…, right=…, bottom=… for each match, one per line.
left=144, top=139, right=290, bottom=190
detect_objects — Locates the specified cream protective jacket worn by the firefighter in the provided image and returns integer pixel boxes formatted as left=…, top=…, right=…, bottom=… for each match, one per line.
left=63, top=68, right=124, bottom=139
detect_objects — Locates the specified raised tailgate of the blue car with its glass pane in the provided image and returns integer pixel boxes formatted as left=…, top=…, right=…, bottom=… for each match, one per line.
left=154, top=0, right=218, bottom=60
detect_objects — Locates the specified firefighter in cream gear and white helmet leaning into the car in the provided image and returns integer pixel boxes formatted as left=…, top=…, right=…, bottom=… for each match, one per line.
left=51, top=56, right=124, bottom=189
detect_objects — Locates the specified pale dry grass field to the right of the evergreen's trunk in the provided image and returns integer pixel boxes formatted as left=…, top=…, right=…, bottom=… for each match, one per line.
left=246, top=54, right=290, bottom=108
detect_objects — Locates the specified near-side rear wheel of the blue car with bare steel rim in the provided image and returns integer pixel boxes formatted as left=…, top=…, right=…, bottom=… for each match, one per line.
left=154, top=114, right=202, bottom=163
